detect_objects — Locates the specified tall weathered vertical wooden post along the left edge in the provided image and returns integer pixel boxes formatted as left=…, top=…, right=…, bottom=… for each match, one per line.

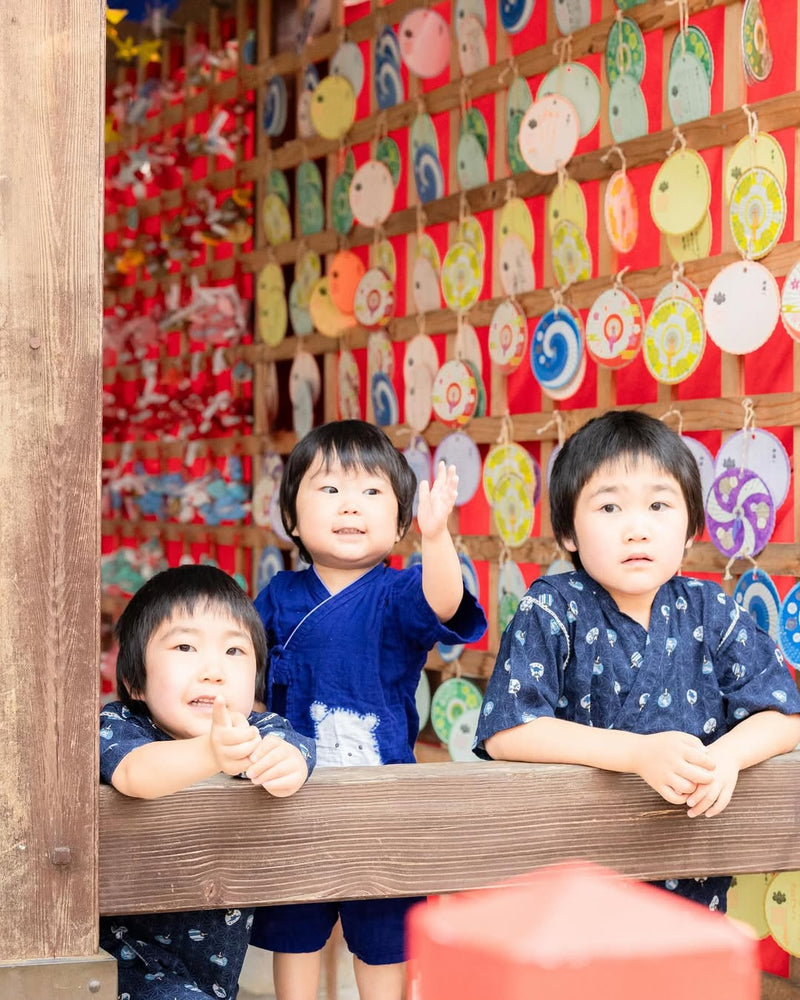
left=0, top=0, right=116, bottom=1000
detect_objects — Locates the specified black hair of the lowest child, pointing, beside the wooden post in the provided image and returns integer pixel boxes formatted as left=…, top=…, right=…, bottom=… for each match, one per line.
left=115, top=565, right=267, bottom=713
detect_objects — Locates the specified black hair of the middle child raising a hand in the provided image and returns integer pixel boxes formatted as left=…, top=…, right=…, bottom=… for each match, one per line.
left=279, top=420, right=417, bottom=563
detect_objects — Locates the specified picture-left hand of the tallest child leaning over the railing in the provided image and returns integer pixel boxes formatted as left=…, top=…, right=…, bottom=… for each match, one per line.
left=633, top=732, right=716, bottom=815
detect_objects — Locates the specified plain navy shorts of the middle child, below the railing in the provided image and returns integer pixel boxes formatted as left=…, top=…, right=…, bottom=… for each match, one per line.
left=250, top=896, right=425, bottom=965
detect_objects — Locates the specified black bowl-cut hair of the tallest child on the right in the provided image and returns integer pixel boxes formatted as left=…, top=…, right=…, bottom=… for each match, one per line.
left=549, top=410, right=705, bottom=569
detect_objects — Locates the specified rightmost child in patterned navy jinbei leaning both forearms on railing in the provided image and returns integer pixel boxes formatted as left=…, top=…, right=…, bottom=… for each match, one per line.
left=476, top=411, right=800, bottom=910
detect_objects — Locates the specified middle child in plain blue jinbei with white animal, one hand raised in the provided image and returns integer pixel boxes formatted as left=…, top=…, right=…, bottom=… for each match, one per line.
left=252, top=420, right=486, bottom=1000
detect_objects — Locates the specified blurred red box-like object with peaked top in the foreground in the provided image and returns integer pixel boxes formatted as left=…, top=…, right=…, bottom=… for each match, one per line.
left=408, top=862, right=760, bottom=1000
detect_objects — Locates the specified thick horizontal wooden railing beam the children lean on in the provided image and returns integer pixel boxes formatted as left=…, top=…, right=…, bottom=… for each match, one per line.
left=100, top=752, right=800, bottom=913
